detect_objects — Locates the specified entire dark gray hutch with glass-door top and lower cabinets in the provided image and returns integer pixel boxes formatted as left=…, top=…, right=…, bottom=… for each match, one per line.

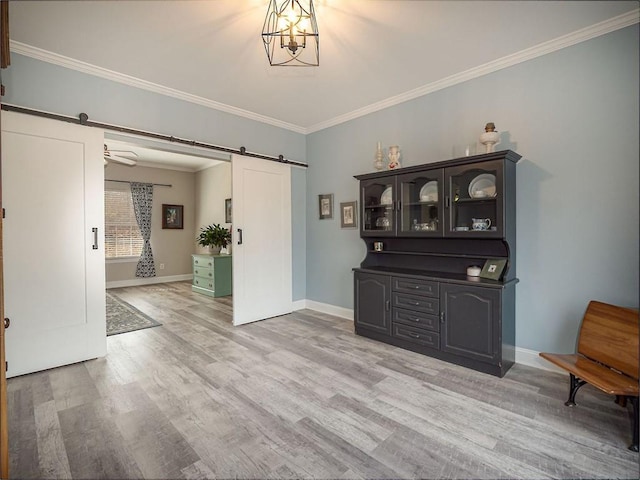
left=354, top=150, right=520, bottom=377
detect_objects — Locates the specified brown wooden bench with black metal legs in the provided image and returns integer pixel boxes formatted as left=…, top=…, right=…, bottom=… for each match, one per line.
left=540, top=301, right=638, bottom=452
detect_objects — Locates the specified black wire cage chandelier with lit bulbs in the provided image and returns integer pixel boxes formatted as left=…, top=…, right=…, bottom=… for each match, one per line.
left=262, top=0, right=320, bottom=67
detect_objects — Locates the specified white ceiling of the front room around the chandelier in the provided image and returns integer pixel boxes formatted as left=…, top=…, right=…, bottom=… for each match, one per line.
left=9, top=0, right=638, bottom=133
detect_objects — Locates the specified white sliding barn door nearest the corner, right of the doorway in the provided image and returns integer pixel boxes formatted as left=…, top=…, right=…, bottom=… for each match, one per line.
left=231, top=155, right=292, bottom=325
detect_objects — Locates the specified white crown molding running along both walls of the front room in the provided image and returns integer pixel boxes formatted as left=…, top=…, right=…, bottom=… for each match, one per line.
left=10, top=9, right=640, bottom=135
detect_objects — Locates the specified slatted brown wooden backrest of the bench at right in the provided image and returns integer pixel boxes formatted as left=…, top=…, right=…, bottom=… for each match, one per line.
left=578, top=300, right=638, bottom=379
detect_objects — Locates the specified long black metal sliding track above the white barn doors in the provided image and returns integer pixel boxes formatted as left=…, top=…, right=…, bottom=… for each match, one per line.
left=2, top=103, right=308, bottom=168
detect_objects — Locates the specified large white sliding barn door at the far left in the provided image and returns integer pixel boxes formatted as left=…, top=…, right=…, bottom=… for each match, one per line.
left=2, top=112, right=106, bottom=377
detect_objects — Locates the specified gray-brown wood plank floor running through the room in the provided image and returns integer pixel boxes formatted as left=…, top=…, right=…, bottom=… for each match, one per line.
left=8, top=282, right=638, bottom=479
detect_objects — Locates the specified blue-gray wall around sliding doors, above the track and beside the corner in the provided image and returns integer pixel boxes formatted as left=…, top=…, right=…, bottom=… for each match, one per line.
left=2, top=53, right=306, bottom=300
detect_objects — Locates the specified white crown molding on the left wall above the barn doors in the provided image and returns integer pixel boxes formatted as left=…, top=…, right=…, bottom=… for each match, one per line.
left=10, top=40, right=306, bottom=134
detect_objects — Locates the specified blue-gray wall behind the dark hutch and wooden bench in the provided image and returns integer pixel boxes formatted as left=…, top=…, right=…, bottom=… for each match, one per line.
left=307, top=25, right=639, bottom=351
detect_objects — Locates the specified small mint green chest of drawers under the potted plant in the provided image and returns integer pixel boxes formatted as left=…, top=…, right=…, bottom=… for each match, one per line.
left=191, top=254, right=232, bottom=297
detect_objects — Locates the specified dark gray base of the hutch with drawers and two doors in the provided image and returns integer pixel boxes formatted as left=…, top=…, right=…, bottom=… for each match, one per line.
left=354, top=269, right=516, bottom=377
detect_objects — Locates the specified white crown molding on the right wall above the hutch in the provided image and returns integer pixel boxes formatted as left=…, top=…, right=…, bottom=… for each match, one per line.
left=307, top=9, right=640, bottom=134
